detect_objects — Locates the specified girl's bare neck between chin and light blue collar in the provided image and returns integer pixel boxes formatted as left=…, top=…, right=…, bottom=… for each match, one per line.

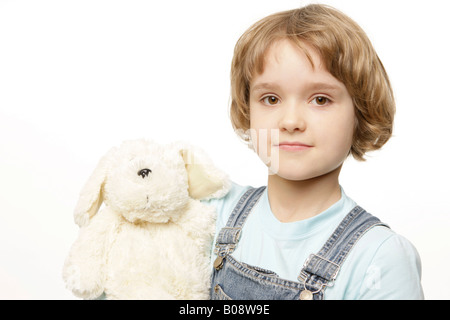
left=267, top=167, right=341, bottom=222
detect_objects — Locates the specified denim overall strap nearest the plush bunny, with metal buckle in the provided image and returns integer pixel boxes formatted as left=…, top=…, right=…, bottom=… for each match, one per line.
left=214, top=187, right=266, bottom=257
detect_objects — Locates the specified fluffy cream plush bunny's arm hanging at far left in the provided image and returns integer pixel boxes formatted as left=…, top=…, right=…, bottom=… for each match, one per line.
left=63, top=207, right=118, bottom=299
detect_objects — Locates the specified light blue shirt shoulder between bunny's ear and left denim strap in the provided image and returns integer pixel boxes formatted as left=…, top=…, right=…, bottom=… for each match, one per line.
left=202, top=182, right=251, bottom=226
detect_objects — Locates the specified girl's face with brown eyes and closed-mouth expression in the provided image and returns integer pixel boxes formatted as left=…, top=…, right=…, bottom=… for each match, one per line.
left=250, top=40, right=355, bottom=181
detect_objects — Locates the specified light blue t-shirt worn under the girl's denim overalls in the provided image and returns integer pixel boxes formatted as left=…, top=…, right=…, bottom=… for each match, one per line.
left=206, top=184, right=423, bottom=300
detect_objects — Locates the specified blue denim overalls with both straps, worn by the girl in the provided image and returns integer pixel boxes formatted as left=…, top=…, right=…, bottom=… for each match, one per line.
left=211, top=187, right=387, bottom=300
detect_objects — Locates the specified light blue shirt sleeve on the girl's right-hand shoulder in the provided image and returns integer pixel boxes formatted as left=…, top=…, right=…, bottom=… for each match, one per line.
left=345, top=226, right=423, bottom=300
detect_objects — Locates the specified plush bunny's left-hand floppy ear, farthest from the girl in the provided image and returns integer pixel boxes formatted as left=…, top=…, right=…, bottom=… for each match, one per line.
left=74, top=148, right=116, bottom=227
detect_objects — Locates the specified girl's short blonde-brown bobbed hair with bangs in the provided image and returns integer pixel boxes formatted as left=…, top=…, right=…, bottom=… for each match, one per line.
left=230, top=4, right=395, bottom=161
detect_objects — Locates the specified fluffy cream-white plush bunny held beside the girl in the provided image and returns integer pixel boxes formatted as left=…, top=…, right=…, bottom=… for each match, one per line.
left=63, top=140, right=230, bottom=299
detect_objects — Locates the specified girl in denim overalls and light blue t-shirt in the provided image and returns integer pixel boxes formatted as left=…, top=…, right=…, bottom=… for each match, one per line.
left=206, top=5, right=423, bottom=300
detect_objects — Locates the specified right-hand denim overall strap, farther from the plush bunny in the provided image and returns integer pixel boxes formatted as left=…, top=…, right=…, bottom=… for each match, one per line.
left=298, top=206, right=388, bottom=289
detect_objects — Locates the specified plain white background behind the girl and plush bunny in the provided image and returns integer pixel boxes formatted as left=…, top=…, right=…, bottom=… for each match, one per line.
left=0, top=0, right=450, bottom=299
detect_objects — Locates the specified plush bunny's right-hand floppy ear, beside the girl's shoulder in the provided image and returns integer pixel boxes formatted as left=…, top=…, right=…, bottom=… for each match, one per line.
left=180, top=145, right=231, bottom=200
